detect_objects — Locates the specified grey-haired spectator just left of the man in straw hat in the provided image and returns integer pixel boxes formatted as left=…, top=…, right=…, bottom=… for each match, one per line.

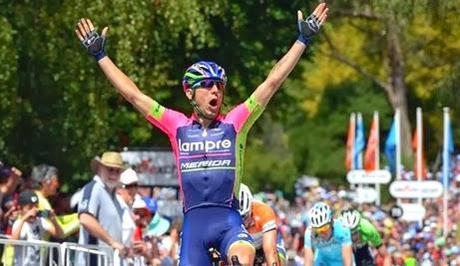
left=31, top=164, right=80, bottom=236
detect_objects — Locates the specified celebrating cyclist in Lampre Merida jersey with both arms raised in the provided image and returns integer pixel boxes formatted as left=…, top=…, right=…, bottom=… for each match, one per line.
left=75, top=3, right=328, bottom=266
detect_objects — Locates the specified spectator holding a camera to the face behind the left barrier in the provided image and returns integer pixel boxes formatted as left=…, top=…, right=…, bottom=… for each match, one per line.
left=11, top=190, right=64, bottom=265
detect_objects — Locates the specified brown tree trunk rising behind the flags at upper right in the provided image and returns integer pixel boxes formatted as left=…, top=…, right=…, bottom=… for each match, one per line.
left=387, top=21, right=413, bottom=158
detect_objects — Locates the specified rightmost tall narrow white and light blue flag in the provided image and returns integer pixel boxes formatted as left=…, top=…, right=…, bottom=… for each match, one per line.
left=442, top=107, right=450, bottom=237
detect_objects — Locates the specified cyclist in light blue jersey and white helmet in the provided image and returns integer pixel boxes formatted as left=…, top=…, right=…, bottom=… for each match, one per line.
left=304, top=202, right=353, bottom=266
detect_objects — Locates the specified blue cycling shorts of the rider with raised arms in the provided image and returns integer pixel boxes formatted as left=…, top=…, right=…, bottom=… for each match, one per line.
left=179, top=206, right=252, bottom=266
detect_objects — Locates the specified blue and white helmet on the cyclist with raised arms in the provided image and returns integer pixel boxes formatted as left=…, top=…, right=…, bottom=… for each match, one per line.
left=182, top=61, right=227, bottom=91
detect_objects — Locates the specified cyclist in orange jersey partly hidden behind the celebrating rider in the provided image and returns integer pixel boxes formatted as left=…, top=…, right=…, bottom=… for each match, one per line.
left=239, top=184, right=286, bottom=266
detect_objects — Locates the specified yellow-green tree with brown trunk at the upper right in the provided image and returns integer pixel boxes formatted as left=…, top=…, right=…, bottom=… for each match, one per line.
left=307, top=1, right=460, bottom=160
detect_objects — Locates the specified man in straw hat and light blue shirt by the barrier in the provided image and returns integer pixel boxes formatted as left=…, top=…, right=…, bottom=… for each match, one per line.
left=77, top=152, right=125, bottom=265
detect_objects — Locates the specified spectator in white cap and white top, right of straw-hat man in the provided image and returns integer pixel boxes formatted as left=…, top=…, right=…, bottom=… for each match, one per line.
left=117, top=168, right=139, bottom=246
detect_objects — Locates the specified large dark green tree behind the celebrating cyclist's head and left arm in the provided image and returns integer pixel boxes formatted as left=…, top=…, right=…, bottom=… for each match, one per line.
left=0, top=0, right=312, bottom=190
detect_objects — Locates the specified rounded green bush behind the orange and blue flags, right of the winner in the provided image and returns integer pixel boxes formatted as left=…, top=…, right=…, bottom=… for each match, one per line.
left=288, top=82, right=392, bottom=183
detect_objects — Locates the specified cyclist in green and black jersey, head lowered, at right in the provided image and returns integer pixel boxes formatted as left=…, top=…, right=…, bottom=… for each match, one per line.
left=340, top=209, right=391, bottom=266
